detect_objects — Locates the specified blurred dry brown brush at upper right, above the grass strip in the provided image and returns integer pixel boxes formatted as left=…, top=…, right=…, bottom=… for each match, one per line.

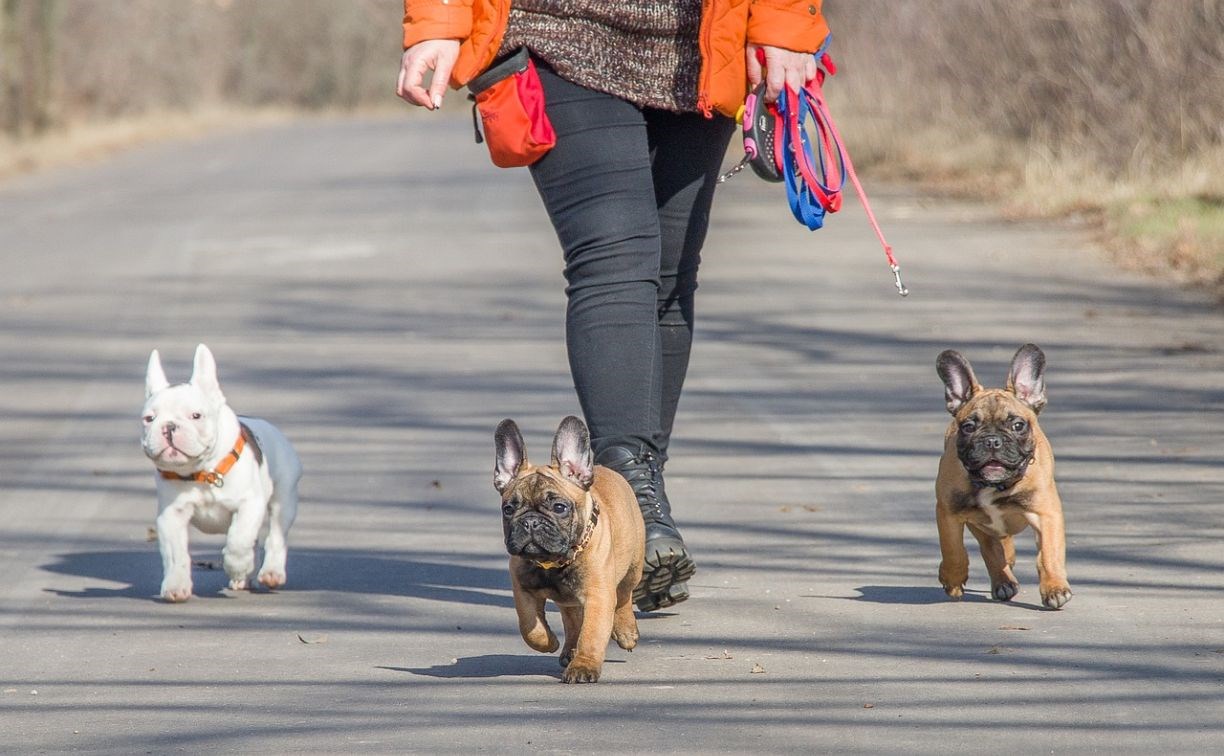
left=826, top=0, right=1224, bottom=191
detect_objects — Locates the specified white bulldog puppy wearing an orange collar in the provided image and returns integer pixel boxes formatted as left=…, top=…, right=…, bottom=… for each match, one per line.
left=142, top=344, right=302, bottom=602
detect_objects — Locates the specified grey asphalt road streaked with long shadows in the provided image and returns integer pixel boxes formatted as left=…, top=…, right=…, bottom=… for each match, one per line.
left=0, top=116, right=1224, bottom=754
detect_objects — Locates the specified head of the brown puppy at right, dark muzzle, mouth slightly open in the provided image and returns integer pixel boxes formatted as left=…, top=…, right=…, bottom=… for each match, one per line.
left=936, top=344, right=1045, bottom=487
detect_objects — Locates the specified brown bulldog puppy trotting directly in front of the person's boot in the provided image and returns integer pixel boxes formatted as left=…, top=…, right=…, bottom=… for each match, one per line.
left=493, top=416, right=645, bottom=683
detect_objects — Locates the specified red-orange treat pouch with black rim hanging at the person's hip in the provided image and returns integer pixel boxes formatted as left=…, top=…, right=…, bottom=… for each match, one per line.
left=468, top=48, right=557, bottom=168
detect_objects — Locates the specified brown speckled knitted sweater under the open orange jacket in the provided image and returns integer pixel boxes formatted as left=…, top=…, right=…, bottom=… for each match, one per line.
left=501, top=0, right=701, bottom=113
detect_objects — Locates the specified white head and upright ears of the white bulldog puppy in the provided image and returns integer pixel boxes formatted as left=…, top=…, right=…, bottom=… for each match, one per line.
left=141, top=345, right=225, bottom=471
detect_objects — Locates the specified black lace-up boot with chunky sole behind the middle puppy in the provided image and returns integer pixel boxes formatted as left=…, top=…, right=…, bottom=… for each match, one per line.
left=595, top=447, right=696, bottom=612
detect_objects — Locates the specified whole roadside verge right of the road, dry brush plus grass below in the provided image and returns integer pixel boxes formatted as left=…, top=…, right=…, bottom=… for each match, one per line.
left=826, top=0, right=1224, bottom=292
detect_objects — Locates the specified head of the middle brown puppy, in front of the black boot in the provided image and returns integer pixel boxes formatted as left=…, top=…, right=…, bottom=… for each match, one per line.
left=493, top=417, right=594, bottom=560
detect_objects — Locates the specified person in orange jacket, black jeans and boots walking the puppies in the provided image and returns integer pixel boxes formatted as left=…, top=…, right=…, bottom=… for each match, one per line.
left=397, top=0, right=829, bottom=612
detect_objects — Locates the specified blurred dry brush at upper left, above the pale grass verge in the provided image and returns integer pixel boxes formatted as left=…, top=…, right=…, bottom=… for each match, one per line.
left=0, top=0, right=403, bottom=133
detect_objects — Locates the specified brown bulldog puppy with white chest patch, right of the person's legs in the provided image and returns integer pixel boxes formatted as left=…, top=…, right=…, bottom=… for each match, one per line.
left=935, top=344, right=1071, bottom=609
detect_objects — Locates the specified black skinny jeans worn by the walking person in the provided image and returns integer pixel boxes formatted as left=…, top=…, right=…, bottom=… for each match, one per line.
left=531, top=66, right=734, bottom=460
